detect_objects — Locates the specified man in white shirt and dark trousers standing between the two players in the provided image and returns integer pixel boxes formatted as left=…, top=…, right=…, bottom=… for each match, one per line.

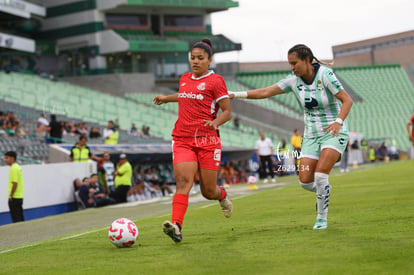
left=256, top=131, right=276, bottom=183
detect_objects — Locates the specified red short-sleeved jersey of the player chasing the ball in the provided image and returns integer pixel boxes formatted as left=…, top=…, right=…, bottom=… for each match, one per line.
left=172, top=71, right=229, bottom=137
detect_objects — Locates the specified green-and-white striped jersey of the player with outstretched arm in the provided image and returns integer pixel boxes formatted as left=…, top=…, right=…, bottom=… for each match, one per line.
left=277, top=64, right=348, bottom=138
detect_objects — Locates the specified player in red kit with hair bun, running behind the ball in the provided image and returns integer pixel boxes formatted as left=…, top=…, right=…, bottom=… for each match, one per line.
left=153, top=39, right=233, bottom=243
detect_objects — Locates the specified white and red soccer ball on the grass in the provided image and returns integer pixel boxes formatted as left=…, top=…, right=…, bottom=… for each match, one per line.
left=108, top=218, right=138, bottom=247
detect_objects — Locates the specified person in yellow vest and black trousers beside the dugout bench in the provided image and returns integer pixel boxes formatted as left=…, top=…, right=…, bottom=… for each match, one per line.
left=111, top=154, right=132, bottom=202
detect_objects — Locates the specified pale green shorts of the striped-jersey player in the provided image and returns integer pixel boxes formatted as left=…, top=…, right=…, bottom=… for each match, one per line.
left=300, top=132, right=349, bottom=159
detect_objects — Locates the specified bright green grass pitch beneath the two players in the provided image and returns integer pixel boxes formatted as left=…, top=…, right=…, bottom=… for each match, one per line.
left=0, top=161, right=414, bottom=274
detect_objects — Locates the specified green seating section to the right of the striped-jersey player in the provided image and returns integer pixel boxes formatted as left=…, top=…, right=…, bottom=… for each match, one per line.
left=335, top=65, right=414, bottom=150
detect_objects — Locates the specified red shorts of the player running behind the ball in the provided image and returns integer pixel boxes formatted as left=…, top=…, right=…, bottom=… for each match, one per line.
left=172, top=136, right=221, bottom=171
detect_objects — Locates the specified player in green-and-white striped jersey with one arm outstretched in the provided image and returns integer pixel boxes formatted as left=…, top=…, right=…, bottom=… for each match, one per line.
left=231, top=44, right=353, bottom=230
